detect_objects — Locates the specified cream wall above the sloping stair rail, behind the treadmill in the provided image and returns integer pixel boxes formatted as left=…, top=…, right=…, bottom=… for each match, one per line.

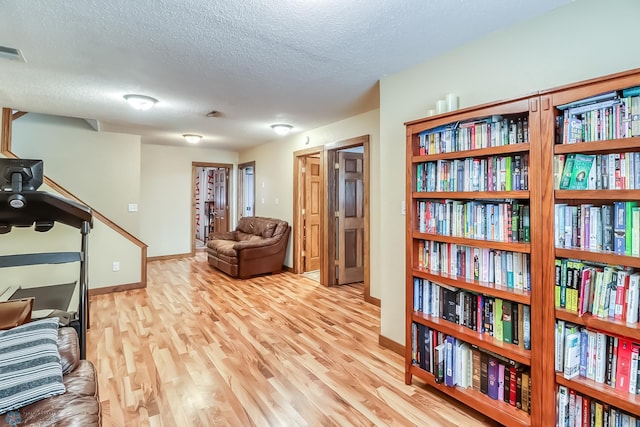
left=11, top=113, right=140, bottom=237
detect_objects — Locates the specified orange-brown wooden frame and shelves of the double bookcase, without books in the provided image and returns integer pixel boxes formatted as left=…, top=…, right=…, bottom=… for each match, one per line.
left=405, top=69, right=640, bottom=426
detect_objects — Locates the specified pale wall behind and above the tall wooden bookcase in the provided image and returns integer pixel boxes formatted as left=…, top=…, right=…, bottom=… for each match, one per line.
left=372, top=0, right=640, bottom=343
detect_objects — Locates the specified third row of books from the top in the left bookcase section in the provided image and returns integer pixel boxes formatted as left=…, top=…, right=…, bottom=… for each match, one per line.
left=417, top=200, right=531, bottom=242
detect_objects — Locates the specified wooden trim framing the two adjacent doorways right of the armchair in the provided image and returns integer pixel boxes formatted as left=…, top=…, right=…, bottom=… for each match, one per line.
left=293, top=135, right=380, bottom=307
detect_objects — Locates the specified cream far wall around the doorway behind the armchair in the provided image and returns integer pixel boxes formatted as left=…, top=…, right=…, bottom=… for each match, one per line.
left=140, top=144, right=238, bottom=257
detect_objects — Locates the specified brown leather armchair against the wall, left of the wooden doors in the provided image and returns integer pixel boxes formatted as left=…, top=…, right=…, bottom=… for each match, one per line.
left=207, top=216, right=291, bottom=279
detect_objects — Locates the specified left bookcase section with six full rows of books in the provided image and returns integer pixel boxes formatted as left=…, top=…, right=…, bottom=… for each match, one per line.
left=405, top=98, right=541, bottom=426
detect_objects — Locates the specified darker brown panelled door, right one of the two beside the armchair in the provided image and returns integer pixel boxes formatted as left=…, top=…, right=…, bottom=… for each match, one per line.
left=336, top=151, right=364, bottom=285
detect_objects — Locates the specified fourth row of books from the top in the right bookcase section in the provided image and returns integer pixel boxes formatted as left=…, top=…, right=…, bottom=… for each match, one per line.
left=554, top=259, right=640, bottom=324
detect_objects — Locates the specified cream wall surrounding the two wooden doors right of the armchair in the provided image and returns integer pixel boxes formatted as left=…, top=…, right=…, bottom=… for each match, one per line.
left=239, top=110, right=380, bottom=298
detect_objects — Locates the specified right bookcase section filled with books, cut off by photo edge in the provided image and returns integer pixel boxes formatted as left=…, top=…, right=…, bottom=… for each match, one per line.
left=542, top=71, right=640, bottom=427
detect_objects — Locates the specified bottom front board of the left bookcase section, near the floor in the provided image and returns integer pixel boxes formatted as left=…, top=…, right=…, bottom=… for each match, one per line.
left=410, top=366, right=535, bottom=426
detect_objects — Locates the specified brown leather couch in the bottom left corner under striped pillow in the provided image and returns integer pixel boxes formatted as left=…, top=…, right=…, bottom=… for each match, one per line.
left=0, top=327, right=102, bottom=427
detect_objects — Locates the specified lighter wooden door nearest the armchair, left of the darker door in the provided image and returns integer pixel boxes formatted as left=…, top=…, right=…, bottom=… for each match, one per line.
left=303, top=157, right=322, bottom=271
